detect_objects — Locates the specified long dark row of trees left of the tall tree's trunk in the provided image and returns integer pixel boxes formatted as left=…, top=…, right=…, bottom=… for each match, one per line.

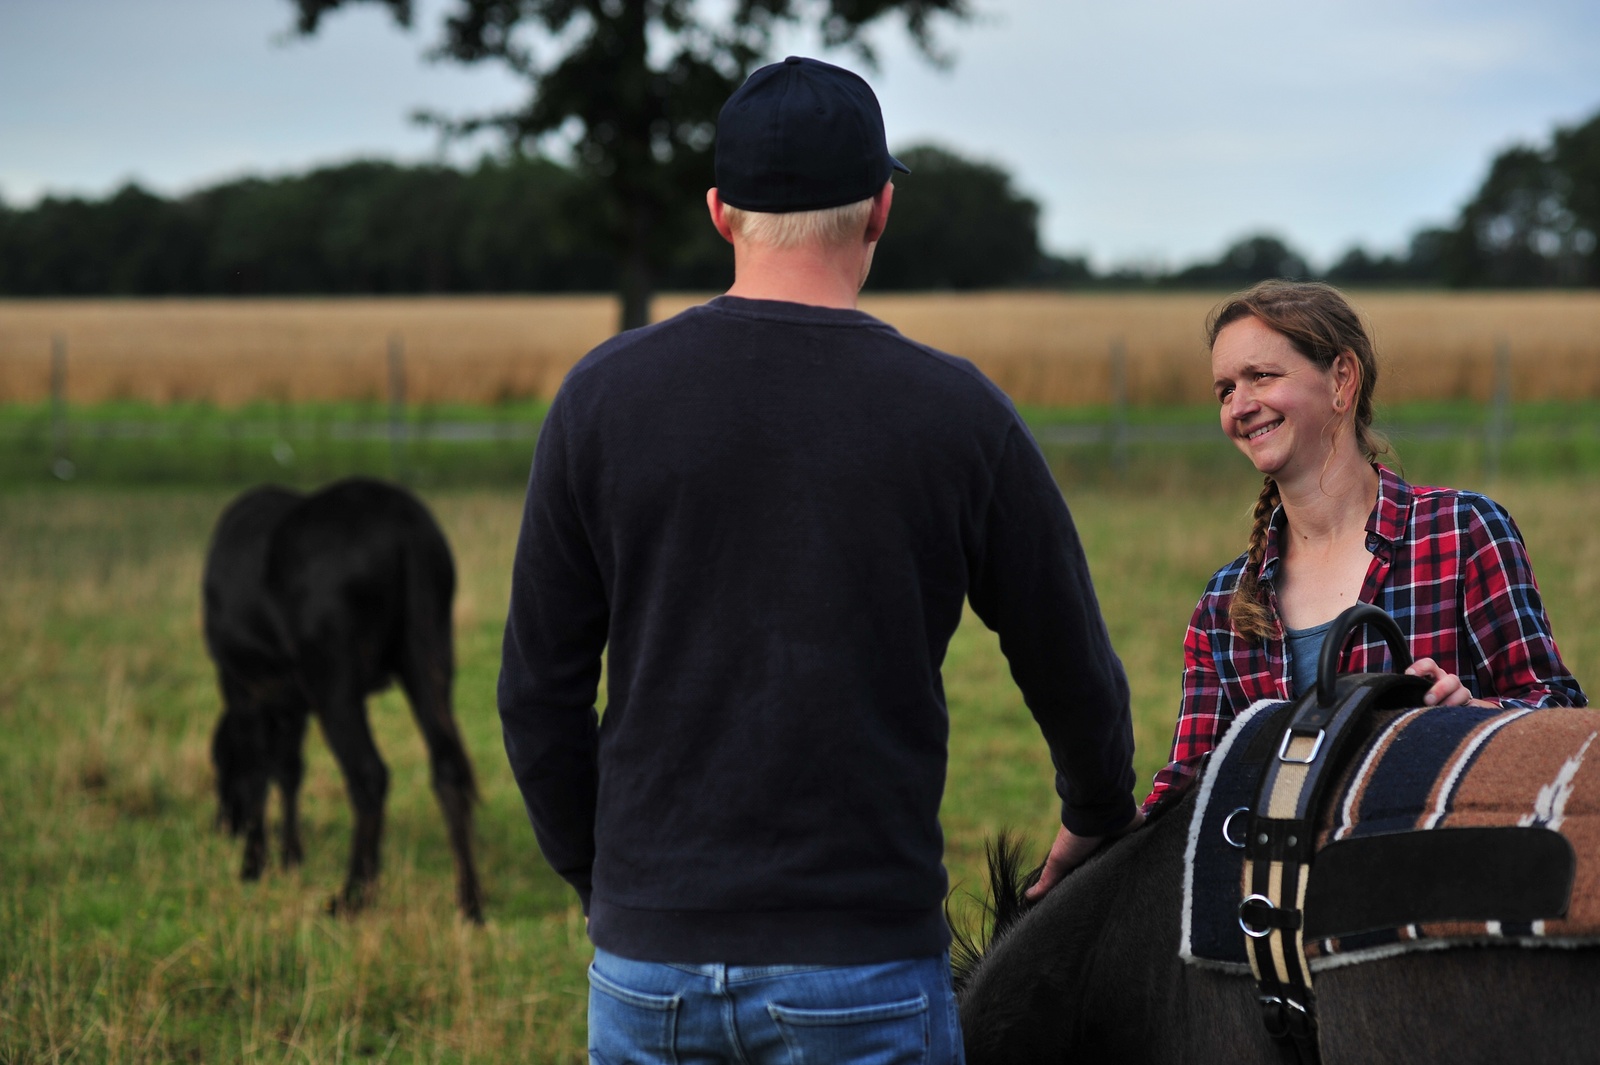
left=0, top=158, right=614, bottom=296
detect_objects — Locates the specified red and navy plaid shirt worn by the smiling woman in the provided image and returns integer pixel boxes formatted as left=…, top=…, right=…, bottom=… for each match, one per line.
left=1146, top=465, right=1587, bottom=804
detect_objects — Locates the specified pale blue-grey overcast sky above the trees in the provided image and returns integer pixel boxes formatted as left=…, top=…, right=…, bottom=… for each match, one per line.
left=0, top=0, right=1600, bottom=269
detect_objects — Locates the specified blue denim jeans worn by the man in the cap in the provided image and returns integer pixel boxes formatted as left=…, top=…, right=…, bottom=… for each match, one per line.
left=589, top=950, right=966, bottom=1065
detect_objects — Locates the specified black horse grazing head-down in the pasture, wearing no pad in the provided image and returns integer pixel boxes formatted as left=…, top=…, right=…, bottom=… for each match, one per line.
left=203, top=478, right=482, bottom=921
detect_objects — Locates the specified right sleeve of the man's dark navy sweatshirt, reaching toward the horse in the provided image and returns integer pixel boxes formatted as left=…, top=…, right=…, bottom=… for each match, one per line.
left=970, top=422, right=1134, bottom=836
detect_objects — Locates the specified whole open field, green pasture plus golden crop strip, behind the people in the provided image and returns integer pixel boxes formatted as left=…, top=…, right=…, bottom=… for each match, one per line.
left=0, top=293, right=1600, bottom=1065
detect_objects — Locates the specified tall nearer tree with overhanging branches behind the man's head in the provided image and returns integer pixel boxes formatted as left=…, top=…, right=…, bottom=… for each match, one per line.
left=281, top=0, right=970, bottom=328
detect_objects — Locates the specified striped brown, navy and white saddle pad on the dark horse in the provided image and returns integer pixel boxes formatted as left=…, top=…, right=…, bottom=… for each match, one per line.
left=1179, top=702, right=1600, bottom=972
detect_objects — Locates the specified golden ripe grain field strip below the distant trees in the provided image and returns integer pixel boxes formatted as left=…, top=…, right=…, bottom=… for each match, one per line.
left=0, top=293, right=1600, bottom=408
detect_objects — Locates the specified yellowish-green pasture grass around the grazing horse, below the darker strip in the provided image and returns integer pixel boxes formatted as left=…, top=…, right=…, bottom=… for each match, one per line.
left=0, top=411, right=1600, bottom=1063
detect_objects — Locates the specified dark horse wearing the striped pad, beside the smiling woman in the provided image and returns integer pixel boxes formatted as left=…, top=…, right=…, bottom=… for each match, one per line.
left=955, top=792, right=1600, bottom=1065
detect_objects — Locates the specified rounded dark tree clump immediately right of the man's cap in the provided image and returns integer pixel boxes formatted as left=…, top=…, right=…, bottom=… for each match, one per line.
left=867, top=146, right=1042, bottom=289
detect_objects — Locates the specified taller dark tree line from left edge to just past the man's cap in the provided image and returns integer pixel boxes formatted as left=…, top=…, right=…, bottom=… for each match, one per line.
left=0, top=146, right=1050, bottom=296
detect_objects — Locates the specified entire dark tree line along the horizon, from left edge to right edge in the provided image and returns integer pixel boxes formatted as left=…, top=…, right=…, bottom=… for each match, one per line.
left=0, top=114, right=1600, bottom=296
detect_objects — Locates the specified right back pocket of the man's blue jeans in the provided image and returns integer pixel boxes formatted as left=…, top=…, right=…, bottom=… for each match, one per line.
left=766, top=995, right=928, bottom=1065
